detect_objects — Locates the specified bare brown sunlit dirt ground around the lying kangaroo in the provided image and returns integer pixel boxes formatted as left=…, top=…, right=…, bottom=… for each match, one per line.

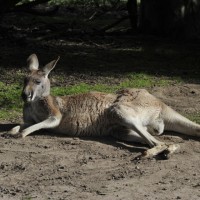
left=0, top=84, right=200, bottom=200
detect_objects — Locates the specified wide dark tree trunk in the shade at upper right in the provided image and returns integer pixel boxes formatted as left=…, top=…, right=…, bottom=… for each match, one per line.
left=139, top=0, right=200, bottom=38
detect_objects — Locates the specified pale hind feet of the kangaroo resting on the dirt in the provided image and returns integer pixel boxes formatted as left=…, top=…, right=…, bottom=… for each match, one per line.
left=135, top=144, right=180, bottom=160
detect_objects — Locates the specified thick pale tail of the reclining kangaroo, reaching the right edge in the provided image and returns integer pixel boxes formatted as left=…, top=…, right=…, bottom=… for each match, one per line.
left=162, top=105, right=200, bottom=137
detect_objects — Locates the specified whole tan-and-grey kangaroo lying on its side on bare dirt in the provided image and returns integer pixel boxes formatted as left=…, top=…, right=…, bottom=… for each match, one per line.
left=6, top=54, right=200, bottom=157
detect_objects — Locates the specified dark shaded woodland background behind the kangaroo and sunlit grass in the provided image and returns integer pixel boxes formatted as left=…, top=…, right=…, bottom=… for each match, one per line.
left=0, top=0, right=200, bottom=83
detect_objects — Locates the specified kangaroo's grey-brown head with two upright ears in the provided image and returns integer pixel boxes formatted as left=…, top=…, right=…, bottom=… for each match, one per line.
left=22, top=54, right=59, bottom=102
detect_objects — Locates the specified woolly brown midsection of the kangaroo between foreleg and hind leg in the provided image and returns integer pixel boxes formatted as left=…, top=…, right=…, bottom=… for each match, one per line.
left=56, top=93, right=115, bottom=136
